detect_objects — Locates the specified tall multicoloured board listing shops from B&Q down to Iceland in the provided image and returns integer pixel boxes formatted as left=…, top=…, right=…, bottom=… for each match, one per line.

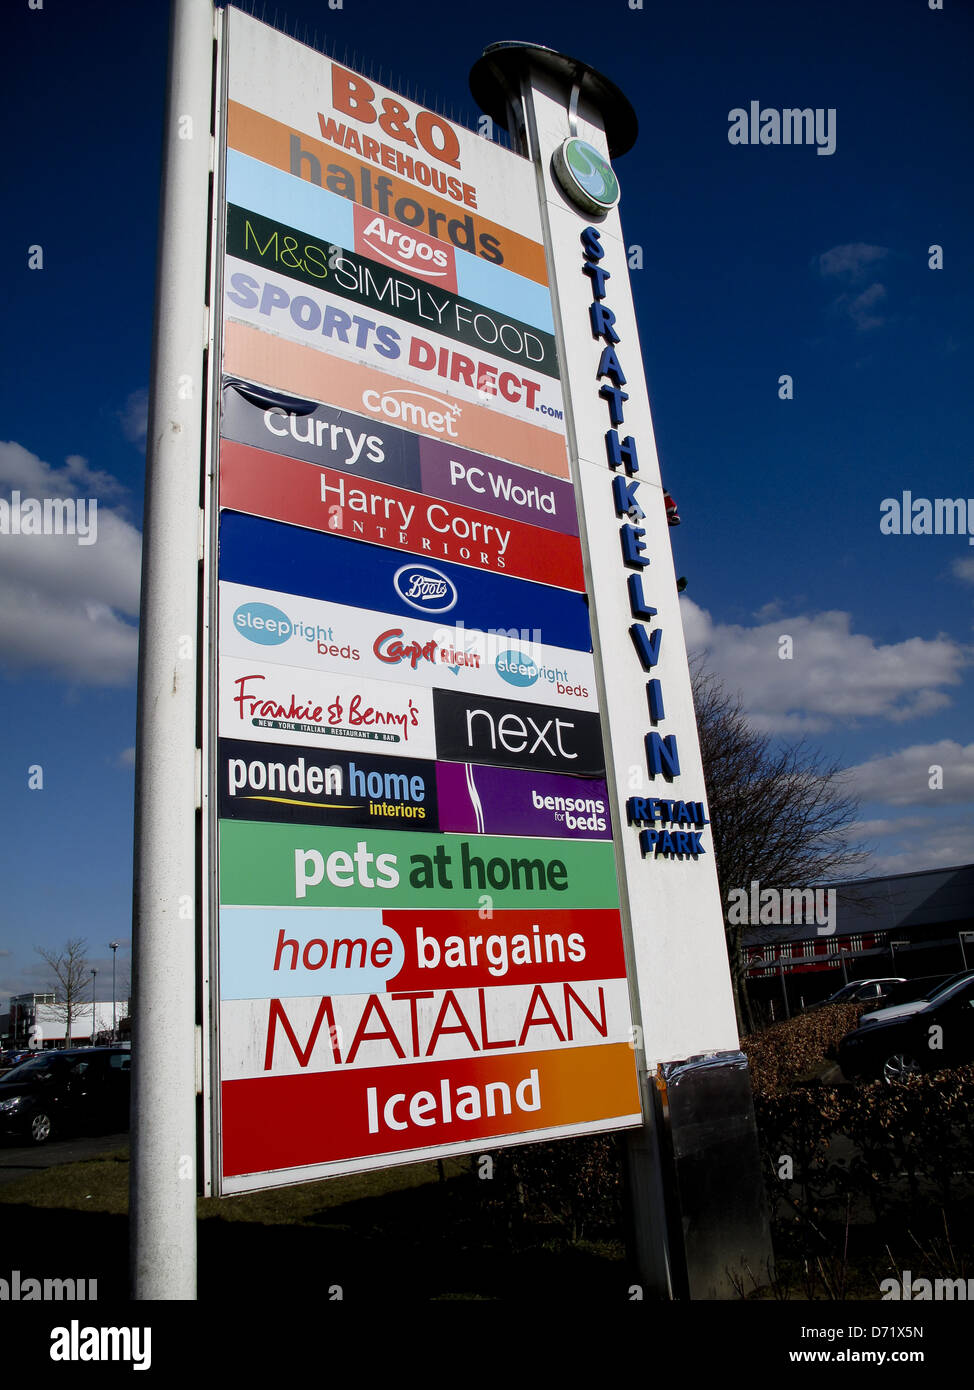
left=207, top=10, right=644, bottom=1193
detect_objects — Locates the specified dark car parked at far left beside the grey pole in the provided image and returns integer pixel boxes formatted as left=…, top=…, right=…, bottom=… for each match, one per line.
left=0, top=1047, right=132, bottom=1144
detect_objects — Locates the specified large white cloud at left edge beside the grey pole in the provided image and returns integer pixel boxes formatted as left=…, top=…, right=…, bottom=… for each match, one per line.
left=0, top=442, right=142, bottom=685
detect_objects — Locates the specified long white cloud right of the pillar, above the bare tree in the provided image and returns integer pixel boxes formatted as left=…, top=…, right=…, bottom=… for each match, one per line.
left=681, top=598, right=970, bottom=734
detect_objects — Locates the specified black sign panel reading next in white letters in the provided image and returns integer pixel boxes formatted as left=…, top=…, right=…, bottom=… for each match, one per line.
left=434, top=691, right=606, bottom=777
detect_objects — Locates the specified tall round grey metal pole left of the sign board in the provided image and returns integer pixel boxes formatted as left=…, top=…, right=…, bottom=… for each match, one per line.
left=129, top=0, right=214, bottom=1300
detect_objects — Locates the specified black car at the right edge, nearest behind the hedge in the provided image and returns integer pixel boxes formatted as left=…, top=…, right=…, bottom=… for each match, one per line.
left=838, top=974, right=974, bottom=1081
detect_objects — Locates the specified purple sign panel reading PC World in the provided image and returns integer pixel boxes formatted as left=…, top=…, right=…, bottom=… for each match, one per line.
left=420, top=439, right=578, bottom=535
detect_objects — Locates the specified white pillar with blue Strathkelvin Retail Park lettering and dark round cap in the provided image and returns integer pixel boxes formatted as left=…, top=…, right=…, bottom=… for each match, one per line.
left=471, top=43, right=768, bottom=1298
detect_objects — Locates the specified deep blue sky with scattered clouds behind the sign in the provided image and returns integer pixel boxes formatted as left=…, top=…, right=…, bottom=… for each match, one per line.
left=0, top=0, right=974, bottom=1009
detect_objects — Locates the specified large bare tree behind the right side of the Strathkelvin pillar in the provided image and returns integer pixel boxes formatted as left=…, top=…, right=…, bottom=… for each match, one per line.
left=692, top=660, right=868, bottom=1033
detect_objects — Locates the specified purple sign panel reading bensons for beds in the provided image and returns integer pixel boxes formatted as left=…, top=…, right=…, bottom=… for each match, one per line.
left=436, top=763, right=613, bottom=840
